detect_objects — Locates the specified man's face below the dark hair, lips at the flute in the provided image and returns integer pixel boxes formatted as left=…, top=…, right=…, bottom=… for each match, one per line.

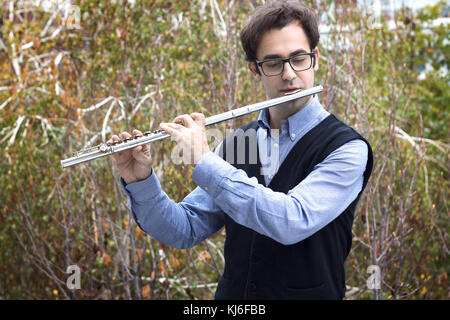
left=249, top=22, right=319, bottom=112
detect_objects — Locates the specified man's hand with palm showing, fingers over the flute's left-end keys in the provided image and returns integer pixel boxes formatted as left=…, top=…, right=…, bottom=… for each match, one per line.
left=111, top=129, right=152, bottom=184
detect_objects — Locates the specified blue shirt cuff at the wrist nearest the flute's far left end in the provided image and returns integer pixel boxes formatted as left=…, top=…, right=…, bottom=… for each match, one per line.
left=120, top=170, right=161, bottom=201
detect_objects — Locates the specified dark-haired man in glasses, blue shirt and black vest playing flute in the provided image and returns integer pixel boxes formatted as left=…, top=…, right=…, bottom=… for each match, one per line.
left=112, top=1, right=372, bottom=299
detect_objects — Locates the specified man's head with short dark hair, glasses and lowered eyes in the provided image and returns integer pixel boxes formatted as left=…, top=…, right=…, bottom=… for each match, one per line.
left=241, top=1, right=320, bottom=113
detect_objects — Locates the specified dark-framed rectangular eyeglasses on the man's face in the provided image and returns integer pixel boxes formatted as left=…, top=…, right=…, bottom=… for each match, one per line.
left=256, top=52, right=315, bottom=77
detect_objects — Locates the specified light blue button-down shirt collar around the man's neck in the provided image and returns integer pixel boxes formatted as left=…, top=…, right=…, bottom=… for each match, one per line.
left=258, top=95, right=323, bottom=140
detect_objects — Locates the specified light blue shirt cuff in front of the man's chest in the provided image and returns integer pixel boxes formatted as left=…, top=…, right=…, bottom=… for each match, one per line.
left=192, top=151, right=236, bottom=198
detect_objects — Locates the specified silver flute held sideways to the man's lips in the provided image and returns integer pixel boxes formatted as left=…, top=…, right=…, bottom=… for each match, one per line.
left=61, top=86, right=323, bottom=168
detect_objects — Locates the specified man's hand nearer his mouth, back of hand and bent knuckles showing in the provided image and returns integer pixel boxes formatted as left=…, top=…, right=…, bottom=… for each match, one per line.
left=159, top=113, right=210, bottom=165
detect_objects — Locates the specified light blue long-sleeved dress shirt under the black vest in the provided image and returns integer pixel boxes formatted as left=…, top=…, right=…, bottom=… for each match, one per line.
left=120, top=97, right=368, bottom=248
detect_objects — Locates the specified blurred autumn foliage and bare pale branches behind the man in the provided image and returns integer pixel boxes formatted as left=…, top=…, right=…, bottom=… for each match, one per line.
left=0, top=0, right=450, bottom=299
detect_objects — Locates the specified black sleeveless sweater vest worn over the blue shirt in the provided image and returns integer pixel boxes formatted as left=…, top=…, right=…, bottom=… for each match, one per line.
left=215, top=115, right=373, bottom=300
